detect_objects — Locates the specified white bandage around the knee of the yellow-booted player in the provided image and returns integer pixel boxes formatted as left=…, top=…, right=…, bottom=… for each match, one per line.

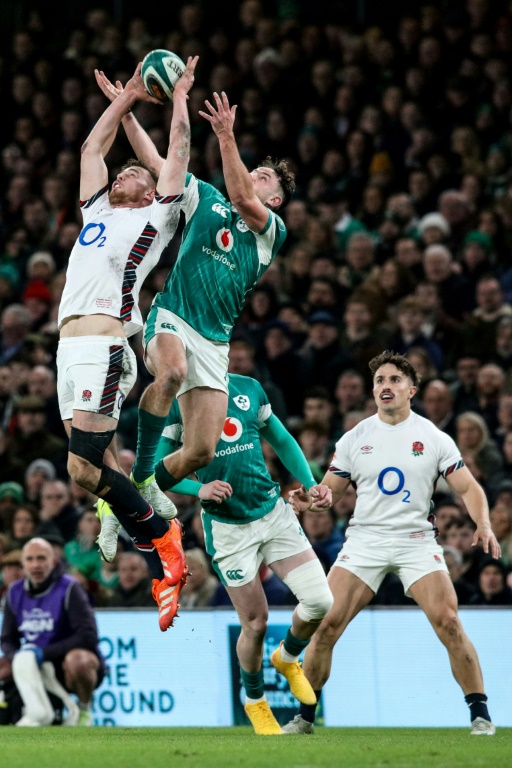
left=284, top=558, right=334, bottom=622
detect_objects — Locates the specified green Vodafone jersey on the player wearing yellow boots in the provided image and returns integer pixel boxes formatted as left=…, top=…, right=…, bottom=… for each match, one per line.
left=159, top=374, right=282, bottom=524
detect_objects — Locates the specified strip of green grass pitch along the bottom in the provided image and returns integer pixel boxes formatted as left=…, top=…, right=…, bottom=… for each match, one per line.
left=0, top=727, right=512, bottom=768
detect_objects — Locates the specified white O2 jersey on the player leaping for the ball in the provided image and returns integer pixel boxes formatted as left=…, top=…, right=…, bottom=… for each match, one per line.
left=58, top=187, right=183, bottom=336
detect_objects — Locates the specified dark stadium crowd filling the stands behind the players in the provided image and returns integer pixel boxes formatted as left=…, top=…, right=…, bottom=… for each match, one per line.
left=0, top=0, right=512, bottom=607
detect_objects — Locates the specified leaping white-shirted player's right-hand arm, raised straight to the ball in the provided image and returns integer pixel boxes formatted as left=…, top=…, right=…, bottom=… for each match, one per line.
left=157, top=56, right=199, bottom=196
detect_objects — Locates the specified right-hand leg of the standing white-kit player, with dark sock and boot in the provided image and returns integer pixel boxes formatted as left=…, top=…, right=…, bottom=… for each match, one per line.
left=409, top=571, right=496, bottom=736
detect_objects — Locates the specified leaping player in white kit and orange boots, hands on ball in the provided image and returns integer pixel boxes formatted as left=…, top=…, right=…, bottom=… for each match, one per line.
left=57, top=57, right=197, bottom=608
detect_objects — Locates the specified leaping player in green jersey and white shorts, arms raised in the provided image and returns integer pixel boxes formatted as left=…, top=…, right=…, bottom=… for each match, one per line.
left=98, top=76, right=295, bottom=516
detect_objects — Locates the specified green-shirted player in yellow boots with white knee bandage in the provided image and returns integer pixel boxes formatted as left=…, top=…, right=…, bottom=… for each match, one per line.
left=98, top=374, right=332, bottom=735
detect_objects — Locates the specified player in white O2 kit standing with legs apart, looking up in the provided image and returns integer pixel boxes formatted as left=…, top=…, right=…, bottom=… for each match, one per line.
left=283, top=352, right=501, bottom=736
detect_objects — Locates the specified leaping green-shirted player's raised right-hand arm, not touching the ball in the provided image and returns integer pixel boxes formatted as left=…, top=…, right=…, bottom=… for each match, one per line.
left=199, top=91, right=269, bottom=232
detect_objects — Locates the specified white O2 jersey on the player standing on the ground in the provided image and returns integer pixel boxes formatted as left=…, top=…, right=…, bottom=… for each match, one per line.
left=329, top=412, right=464, bottom=536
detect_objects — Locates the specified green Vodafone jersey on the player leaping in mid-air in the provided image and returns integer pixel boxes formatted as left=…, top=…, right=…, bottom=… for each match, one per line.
left=154, top=173, right=286, bottom=341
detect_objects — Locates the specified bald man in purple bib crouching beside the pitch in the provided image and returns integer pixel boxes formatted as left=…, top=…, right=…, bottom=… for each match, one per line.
left=1, top=538, right=104, bottom=726
